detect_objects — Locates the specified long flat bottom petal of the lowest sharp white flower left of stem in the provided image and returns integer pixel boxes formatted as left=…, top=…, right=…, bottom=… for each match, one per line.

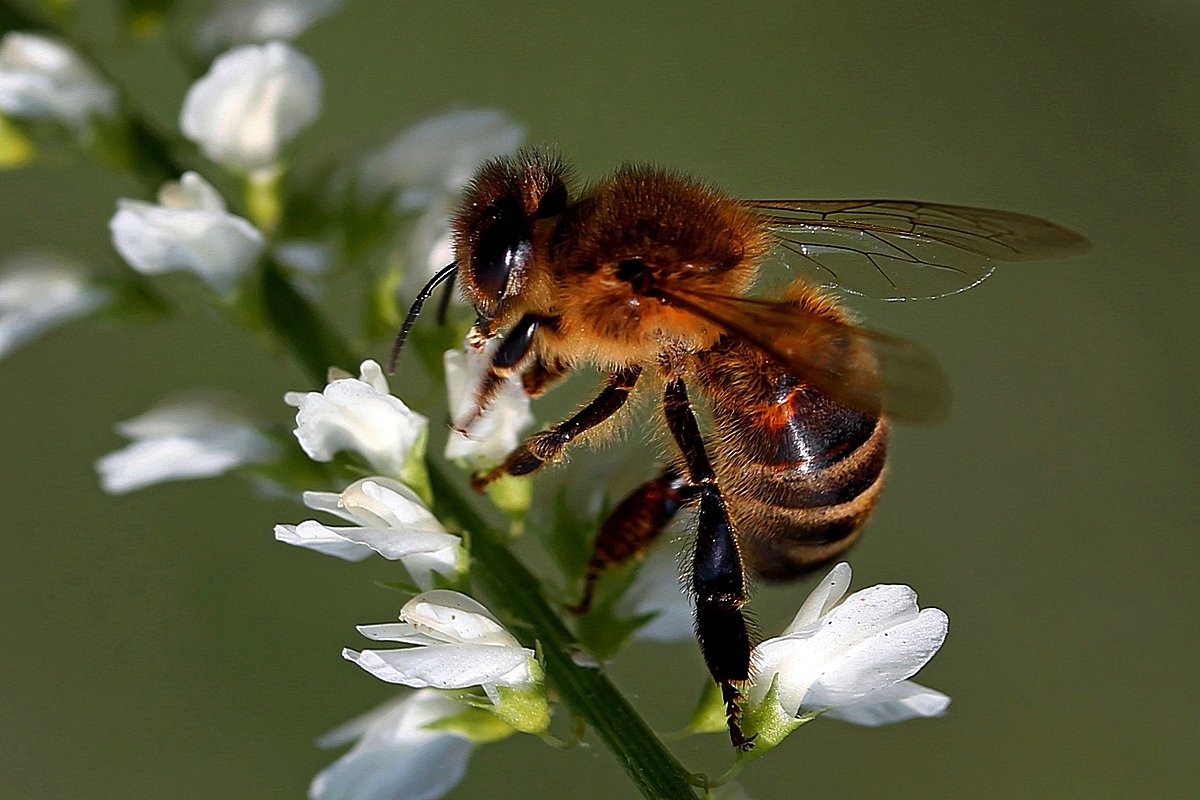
left=342, top=644, right=533, bottom=688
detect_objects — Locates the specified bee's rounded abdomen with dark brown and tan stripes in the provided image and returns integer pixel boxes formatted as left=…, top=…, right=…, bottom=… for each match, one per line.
left=697, top=341, right=888, bottom=578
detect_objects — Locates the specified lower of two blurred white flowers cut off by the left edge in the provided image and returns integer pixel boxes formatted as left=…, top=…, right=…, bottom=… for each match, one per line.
left=0, top=253, right=112, bottom=357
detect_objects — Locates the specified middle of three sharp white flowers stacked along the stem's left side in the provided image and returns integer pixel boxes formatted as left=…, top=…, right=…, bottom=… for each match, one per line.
left=275, top=477, right=467, bottom=589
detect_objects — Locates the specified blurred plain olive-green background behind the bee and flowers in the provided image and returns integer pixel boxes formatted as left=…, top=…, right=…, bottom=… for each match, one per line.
left=0, top=0, right=1200, bottom=800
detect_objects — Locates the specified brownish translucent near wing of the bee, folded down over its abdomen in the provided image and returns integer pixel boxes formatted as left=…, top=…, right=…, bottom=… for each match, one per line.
left=661, top=289, right=950, bottom=422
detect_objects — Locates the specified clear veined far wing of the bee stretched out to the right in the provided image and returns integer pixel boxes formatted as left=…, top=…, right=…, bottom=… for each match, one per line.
left=744, top=200, right=1091, bottom=300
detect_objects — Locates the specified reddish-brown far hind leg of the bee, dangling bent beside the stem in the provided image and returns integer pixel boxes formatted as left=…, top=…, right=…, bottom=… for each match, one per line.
left=568, top=469, right=694, bottom=614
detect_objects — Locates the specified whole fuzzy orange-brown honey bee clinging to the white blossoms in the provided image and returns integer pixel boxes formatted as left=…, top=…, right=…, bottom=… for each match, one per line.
left=391, top=151, right=1087, bottom=748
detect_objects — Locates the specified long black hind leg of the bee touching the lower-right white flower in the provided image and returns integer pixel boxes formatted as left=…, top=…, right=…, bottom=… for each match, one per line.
left=662, top=378, right=754, bottom=750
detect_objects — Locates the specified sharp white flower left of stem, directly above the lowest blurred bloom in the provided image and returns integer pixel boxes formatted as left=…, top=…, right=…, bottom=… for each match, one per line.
left=342, top=589, right=540, bottom=702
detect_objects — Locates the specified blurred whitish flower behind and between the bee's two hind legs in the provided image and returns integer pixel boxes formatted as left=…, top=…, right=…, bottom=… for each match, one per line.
left=614, top=543, right=696, bottom=644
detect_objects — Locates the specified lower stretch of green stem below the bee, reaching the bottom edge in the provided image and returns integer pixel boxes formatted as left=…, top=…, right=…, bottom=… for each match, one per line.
left=430, top=463, right=696, bottom=800
